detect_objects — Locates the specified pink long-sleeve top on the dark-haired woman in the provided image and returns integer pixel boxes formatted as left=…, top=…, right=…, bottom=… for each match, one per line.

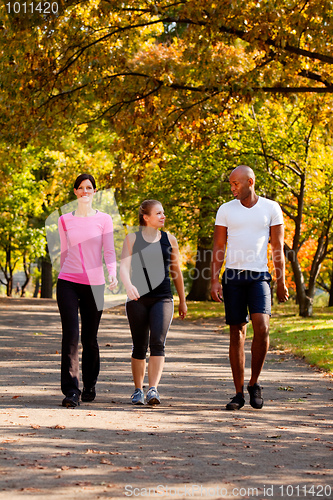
left=58, top=211, right=117, bottom=285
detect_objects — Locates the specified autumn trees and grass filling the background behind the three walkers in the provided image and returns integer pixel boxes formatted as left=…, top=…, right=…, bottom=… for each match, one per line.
left=0, top=0, right=333, bottom=373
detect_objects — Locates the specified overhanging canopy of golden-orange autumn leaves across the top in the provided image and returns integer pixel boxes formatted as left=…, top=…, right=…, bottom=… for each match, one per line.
left=0, top=0, right=333, bottom=145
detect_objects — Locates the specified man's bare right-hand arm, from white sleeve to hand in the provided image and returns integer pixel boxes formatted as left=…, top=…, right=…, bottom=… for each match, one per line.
left=270, top=224, right=289, bottom=302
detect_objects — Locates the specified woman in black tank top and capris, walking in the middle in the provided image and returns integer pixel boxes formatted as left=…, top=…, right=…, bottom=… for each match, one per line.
left=120, top=200, right=187, bottom=405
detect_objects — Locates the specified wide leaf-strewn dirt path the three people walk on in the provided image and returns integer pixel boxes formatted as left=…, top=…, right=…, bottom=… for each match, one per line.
left=0, top=299, right=333, bottom=500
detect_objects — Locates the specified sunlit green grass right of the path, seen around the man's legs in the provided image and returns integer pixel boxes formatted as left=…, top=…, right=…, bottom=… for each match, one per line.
left=175, top=302, right=333, bottom=375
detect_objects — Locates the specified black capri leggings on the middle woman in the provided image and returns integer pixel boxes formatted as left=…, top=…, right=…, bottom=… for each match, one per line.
left=126, top=296, right=173, bottom=359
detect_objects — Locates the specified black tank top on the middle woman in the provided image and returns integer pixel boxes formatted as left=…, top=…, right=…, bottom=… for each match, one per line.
left=131, top=231, right=172, bottom=298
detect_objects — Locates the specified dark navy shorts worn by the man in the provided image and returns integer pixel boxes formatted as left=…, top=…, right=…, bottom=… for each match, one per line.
left=222, top=269, right=272, bottom=325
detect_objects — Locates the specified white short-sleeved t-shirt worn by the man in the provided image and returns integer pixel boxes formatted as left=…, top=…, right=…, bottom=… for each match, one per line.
left=215, top=196, right=283, bottom=272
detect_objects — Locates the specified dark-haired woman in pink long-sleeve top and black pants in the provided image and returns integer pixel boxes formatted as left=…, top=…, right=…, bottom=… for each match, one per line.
left=57, top=174, right=118, bottom=408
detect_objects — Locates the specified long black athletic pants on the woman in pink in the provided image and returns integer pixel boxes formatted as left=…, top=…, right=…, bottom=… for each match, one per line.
left=57, top=279, right=104, bottom=396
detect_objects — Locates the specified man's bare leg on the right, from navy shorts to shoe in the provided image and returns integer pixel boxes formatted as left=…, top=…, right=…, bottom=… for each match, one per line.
left=249, top=313, right=269, bottom=386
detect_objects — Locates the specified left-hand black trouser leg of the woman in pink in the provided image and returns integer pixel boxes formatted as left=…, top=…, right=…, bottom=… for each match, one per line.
left=57, top=280, right=80, bottom=396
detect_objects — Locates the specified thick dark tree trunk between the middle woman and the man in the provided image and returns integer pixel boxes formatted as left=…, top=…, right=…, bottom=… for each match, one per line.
left=186, top=238, right=212, bottom=301
